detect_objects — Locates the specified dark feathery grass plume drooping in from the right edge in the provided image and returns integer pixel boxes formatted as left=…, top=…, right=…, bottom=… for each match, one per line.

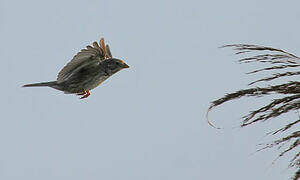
left=206, top=44, right=300, bottom=180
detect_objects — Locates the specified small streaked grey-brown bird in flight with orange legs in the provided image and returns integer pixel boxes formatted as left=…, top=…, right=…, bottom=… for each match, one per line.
left=23, top=38, right=129, bottom=99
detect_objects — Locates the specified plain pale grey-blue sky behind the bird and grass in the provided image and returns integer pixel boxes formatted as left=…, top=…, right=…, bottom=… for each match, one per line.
left=0, top=0, right=300, bottom=180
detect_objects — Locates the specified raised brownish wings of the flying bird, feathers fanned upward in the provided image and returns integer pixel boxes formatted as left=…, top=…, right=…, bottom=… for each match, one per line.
left=57, top=38, right=110, bottom=82
